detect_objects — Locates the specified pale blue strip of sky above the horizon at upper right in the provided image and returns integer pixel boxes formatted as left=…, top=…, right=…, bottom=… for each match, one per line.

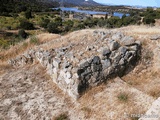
left=94, top=0, right=160, bottom=7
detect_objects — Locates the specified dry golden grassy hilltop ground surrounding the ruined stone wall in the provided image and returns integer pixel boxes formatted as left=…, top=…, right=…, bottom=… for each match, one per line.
left=0, top=26, right=160, bottom=120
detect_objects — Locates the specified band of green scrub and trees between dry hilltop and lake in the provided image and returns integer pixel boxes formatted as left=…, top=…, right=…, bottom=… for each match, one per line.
left=0, top=1, right=160, bottom=49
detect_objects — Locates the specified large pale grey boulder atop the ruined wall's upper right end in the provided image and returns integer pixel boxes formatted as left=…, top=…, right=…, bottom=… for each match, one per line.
left=120, top=36, right=135, bottom=46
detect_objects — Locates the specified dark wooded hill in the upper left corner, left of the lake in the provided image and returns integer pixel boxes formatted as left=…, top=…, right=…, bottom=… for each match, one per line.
left=0, top=0, right=59, bottom=16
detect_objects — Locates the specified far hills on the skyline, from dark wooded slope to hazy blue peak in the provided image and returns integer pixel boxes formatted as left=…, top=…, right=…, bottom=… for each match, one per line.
left=0, top=0, right=101, bottom=15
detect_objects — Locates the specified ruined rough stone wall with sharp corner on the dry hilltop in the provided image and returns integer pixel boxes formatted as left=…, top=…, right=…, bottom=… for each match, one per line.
left=9, top=31, right=141, bottom=99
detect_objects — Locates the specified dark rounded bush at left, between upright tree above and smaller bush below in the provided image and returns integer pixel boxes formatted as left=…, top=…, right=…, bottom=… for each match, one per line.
left=20, top=20, right=34, bottom=30
